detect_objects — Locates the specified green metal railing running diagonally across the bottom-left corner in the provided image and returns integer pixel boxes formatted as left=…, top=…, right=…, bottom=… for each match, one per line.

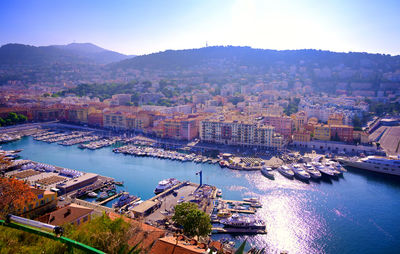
left=0, top=216, right=104, bottom=254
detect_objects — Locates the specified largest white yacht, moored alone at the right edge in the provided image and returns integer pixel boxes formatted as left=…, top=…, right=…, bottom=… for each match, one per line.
left=338, top=156, right=400, bottom=176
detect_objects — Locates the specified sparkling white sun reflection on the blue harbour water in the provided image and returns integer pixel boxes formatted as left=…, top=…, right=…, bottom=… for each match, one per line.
left=239, top=172, right=328, bottom=253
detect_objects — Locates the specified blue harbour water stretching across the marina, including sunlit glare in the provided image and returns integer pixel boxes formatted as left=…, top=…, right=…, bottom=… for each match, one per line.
left=2, top=137, right=400, bottom=253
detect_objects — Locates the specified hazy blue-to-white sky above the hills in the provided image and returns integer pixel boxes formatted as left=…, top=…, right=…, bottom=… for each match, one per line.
left=0, top=0, right=400, bottom=55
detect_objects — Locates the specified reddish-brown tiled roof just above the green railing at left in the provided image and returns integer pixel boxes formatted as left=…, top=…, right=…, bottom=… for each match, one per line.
left=47, top=204, right=94, bottom=226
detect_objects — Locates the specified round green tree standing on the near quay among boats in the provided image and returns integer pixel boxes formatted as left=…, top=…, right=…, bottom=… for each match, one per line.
left=172, top=202, right=211, bottom=237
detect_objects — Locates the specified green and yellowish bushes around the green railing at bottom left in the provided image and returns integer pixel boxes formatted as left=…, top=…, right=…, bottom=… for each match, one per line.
left=0, top=214, right=140, bottom=253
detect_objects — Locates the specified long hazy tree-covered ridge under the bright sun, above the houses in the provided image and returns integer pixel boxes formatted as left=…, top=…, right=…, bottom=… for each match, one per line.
left=110, top=46, right=400, bottom=70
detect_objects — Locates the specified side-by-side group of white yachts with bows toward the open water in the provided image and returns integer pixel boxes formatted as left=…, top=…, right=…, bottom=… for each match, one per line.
left=261, top=160, right=346, bottom=181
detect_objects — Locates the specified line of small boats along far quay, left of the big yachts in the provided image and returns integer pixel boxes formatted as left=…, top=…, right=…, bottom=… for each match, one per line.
left=113, top=145, right=218, bottom=164
